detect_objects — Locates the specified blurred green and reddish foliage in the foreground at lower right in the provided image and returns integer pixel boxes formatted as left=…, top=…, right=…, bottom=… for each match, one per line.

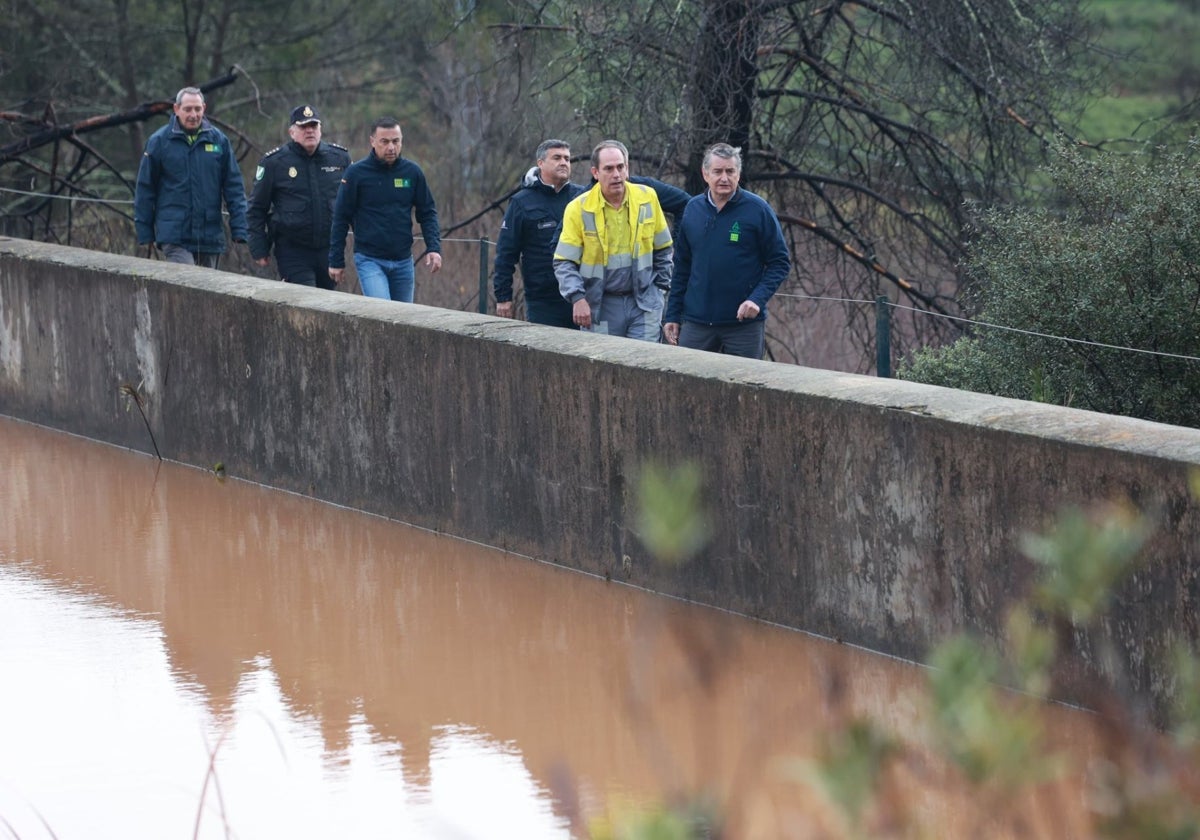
left=588, top=464, right=1200, bottom=840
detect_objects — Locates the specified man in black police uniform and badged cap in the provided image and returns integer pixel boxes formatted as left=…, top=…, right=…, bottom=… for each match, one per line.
left=246, top=104, right=350, bottom=289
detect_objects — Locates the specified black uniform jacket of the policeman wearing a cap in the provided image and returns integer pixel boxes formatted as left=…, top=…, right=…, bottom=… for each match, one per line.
left=246, top=140, right=350, bottom=259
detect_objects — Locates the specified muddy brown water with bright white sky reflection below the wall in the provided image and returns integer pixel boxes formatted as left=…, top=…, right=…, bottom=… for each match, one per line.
left=0, top=419, right=1099, bottom=840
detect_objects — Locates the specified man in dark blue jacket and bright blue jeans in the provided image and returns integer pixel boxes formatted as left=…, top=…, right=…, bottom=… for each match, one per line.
left=329, top=116, right=442, bottom=304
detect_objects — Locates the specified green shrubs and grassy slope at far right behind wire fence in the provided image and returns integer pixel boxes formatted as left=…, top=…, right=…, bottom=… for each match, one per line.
left=899, top=1, right=1200, bottom=426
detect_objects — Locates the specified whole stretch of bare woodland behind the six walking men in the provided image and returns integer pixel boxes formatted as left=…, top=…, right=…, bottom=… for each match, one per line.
left=0, top=0, right=1108, bottom=348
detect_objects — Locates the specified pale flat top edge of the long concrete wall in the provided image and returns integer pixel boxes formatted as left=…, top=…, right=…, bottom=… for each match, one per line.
left=9, top=236, right=1200, bottom=467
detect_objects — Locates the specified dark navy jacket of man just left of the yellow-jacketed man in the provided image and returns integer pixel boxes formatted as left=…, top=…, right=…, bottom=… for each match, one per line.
left=492, top=170, right=584, bottom=304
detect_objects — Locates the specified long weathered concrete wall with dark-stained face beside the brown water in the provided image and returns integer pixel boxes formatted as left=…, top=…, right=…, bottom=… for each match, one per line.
left=0, top=239, right=1200, bottom=715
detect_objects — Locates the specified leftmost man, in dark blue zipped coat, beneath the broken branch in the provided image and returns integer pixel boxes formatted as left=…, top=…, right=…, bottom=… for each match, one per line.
left=133, top=88, right=247, bottom=269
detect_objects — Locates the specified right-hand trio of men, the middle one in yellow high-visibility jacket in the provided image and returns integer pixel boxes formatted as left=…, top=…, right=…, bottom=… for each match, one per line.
left=493, top=139, right=791, bottom=359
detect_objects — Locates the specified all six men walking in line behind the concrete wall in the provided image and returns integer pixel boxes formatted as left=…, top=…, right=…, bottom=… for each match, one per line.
left=134, top=88, right=791, bottom=359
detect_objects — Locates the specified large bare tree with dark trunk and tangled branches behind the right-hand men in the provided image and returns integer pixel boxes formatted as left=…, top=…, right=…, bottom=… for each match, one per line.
left=484, top=0, right=1094, bottom=370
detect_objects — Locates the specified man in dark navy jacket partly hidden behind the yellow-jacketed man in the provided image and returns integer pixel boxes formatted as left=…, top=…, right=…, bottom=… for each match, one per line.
left=492, top=139, right=584, bottom=330
